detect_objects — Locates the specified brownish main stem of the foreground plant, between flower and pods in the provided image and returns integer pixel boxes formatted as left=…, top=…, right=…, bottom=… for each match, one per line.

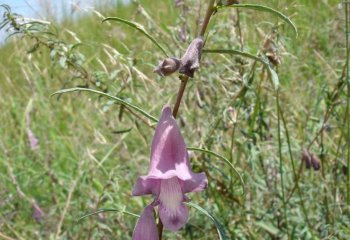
left=158, top=0, right=215, bottom=237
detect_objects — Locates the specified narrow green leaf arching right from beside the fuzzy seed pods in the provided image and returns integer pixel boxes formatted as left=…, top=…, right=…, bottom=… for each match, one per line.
left=203, top=49, right=279, bottom=90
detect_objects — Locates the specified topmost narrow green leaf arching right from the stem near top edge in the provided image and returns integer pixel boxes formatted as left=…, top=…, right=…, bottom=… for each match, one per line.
left=217, top=4, right=298, bottom=37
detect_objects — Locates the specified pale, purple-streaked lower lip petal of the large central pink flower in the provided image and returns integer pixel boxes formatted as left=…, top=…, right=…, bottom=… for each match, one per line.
left=158, top=177, right=188, bottom=232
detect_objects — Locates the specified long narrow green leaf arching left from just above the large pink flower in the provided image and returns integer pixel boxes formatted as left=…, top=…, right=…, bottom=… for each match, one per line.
left=51, top=88, right=158, bottom=122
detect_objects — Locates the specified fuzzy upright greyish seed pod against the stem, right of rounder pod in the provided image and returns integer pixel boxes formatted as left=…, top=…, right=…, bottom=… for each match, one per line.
left=179, top=37, right=204, bottom=78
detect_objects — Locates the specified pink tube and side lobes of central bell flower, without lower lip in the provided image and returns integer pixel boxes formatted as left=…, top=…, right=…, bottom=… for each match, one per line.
left=133, top=106, right=208, bottom=196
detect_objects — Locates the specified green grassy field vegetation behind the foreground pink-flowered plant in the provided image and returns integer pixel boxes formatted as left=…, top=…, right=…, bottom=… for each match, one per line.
left=0, top=0, right=350, bottom=239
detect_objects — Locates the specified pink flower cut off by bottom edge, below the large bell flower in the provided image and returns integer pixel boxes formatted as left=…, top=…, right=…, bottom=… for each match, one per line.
left=132, top=204, right=159, bottom=240
